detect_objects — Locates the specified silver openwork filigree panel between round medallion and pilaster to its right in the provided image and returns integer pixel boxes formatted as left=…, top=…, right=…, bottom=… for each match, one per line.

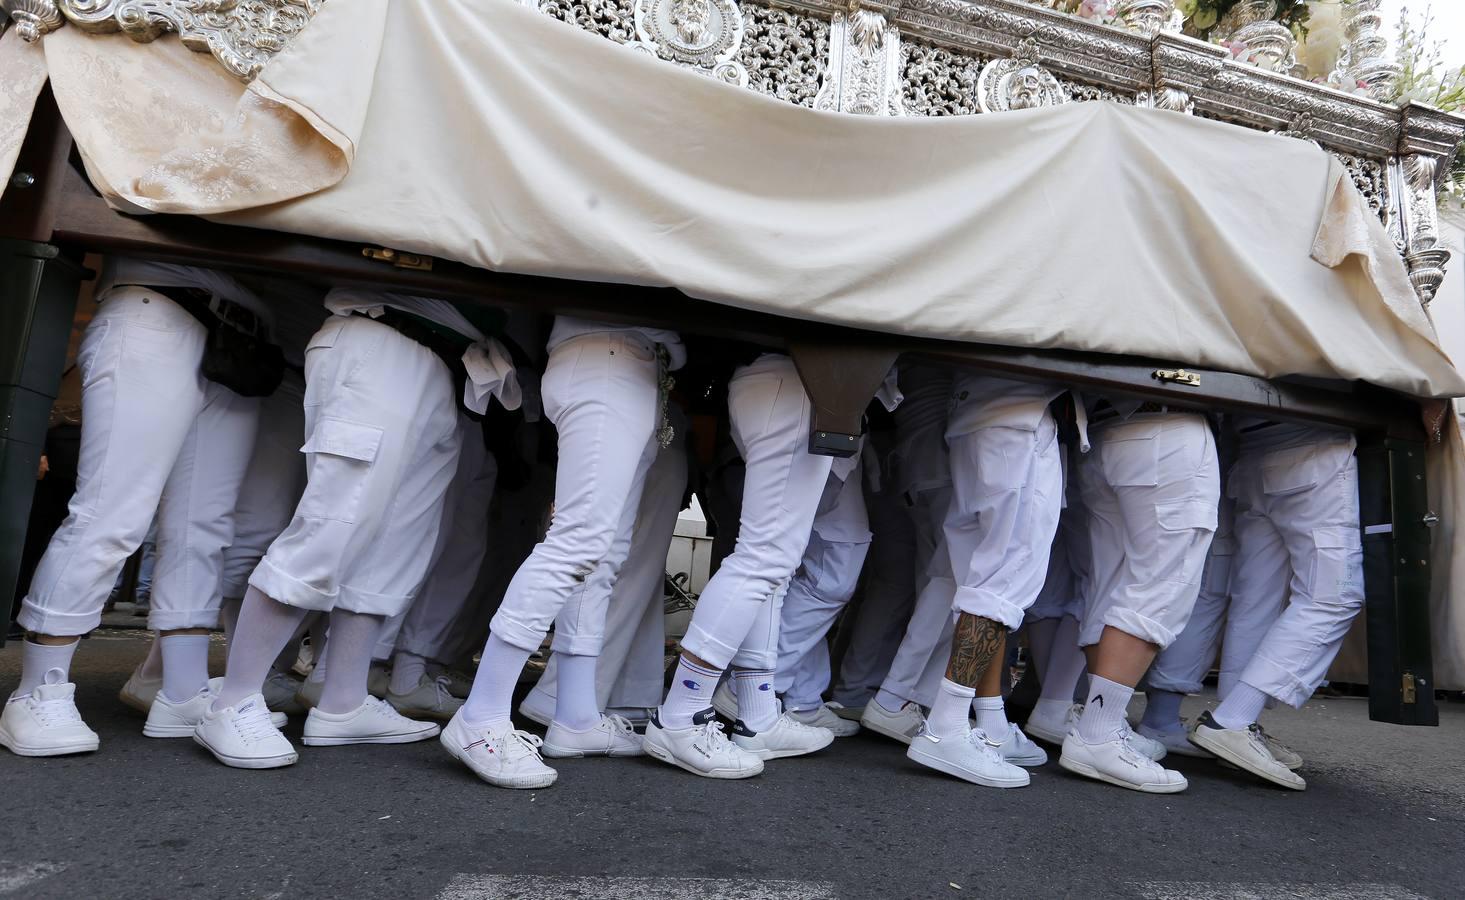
left=737, top=3, right=829, bottom=107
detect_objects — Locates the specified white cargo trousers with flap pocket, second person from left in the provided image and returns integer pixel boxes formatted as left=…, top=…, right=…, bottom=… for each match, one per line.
left=249, top=315, right=459, bottom=616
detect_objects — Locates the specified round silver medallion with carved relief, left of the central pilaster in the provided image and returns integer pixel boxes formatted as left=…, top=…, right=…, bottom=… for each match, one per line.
left=633, top=0, right=747, bottom=86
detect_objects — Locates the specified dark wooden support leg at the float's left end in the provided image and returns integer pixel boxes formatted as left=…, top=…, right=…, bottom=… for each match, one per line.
left=0, top=239, right=82, bottom=642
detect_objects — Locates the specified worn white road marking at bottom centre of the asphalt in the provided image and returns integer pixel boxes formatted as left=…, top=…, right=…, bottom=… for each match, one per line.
left=438, top=875, right=837, bottom=900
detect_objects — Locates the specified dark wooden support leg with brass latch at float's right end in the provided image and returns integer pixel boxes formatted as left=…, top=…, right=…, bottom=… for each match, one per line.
left=1358, top=435, right=1440, bottom=726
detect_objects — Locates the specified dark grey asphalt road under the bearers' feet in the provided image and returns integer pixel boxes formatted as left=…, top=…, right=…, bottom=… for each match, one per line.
left=0, top=632, right=1465, bottom=900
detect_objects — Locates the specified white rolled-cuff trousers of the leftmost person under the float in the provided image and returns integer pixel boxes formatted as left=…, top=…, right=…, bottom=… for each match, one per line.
left=19, top=287, right=259, bottom=636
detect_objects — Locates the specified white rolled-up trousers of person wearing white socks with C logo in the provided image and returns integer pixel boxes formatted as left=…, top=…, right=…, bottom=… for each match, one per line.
left=681, top=353, right=832, bottom=670
